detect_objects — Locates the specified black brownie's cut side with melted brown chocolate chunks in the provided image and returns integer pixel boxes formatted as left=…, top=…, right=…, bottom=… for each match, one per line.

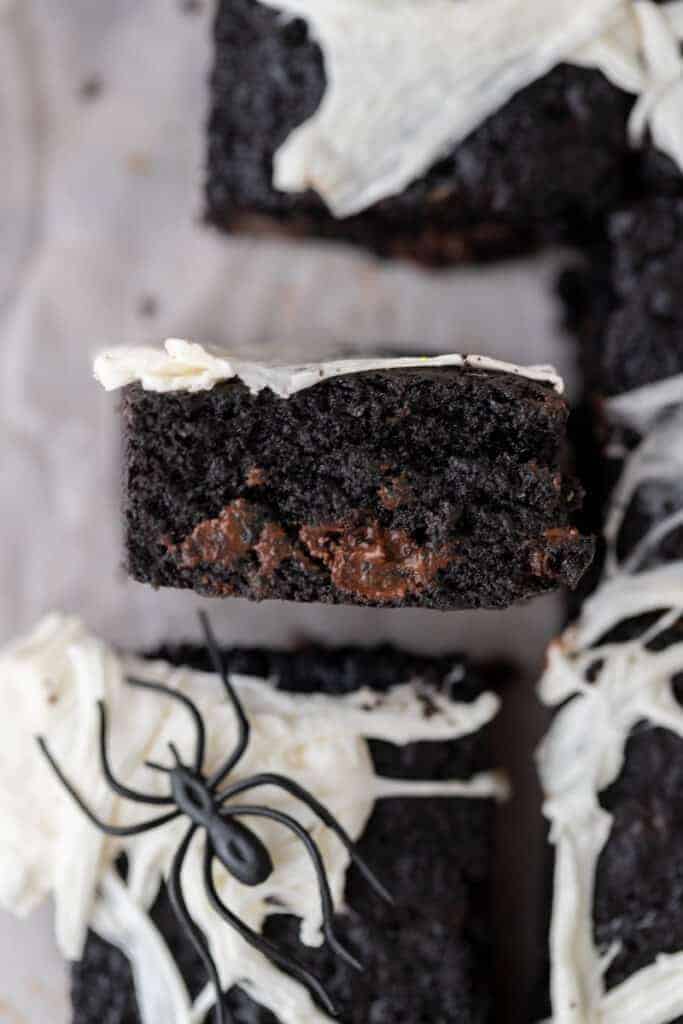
left=123, top=368, right=593, bottom=609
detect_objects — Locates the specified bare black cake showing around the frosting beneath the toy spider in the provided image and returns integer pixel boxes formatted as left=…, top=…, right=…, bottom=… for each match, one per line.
left=72, top=646, right=495, bottom=1024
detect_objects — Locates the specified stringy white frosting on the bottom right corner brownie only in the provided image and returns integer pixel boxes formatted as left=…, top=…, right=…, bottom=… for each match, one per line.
left=538, top=563, right=683, bottom=1024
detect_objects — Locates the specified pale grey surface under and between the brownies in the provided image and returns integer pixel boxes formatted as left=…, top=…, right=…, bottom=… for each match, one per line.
left=0, top=0, right=572, bottom=1024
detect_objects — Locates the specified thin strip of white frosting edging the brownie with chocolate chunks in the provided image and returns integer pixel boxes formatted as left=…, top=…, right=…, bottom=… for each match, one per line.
left=94, top=338, right=564, bottom=398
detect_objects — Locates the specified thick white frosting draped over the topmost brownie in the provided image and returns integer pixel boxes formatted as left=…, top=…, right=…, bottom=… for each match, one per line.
left=264, top=0, right=683, bottom=217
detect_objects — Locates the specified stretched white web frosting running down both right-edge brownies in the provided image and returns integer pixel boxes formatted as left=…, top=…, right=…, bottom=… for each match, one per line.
left=538, top=377, right=683, bottom=1024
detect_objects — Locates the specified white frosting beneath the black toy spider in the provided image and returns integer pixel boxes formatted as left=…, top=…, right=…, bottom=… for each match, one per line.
left=0, top=614, right=506, bottom=1024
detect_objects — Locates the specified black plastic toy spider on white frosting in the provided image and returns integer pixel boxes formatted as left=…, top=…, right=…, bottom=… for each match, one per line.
left=38, top=612, right=391, bottom=1024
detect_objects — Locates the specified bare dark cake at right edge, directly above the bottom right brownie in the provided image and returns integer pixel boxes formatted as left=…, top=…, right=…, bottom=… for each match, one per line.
left=561, top=198, right=683, bottom=598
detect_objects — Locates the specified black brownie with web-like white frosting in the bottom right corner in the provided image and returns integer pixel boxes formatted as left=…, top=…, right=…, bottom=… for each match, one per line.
left=540, top=581, right=683, bottom=1024
